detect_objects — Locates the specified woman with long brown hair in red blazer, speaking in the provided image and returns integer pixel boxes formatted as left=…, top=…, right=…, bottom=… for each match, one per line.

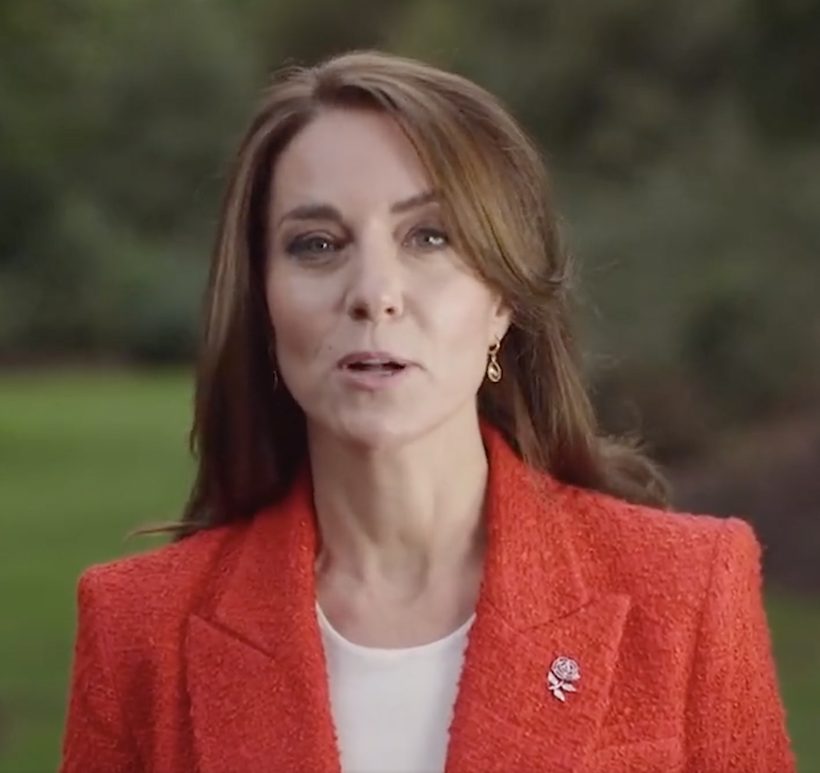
left=62, top=53, right=793, bottom=773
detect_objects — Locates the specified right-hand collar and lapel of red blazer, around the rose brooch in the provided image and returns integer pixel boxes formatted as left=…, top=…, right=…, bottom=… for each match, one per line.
left=446, top=427, right=630, bottom=773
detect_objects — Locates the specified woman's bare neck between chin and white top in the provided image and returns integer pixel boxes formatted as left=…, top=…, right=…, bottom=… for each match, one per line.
left=309, top=415, right=487, bottom=593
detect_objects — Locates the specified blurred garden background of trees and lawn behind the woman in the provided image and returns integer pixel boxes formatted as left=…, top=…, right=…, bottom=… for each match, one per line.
left=0, top=0, right=820, bottom=772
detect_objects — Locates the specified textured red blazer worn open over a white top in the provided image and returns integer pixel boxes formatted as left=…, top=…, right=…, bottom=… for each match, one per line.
left=61, top=428, right=794, bottom=773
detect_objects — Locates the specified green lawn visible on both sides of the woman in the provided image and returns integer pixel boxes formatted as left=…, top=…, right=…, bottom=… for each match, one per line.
left=0, top=372, right=820, bottom=773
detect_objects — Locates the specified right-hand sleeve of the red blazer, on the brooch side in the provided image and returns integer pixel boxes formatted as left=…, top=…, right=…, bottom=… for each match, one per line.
left=686, top=518, right=795, bottom=773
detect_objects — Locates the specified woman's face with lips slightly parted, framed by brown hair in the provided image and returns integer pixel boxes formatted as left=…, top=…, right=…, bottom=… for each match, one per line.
left=265, top=109, right=509, bottom=447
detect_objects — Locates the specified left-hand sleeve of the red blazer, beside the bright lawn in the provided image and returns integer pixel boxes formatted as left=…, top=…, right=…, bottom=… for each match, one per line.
left=60, top=569, right=141, bottom=773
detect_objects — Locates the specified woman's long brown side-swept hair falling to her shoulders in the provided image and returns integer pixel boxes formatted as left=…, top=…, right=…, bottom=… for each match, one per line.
left=177, top=52, right=667, bottom=535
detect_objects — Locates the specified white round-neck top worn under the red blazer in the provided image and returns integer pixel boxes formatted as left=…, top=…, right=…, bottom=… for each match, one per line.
left=316, top=602, right=475, bottom=773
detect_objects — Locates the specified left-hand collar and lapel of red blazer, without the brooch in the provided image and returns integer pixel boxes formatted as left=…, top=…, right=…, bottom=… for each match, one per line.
left=186, top=464, right=340, bottom=773
